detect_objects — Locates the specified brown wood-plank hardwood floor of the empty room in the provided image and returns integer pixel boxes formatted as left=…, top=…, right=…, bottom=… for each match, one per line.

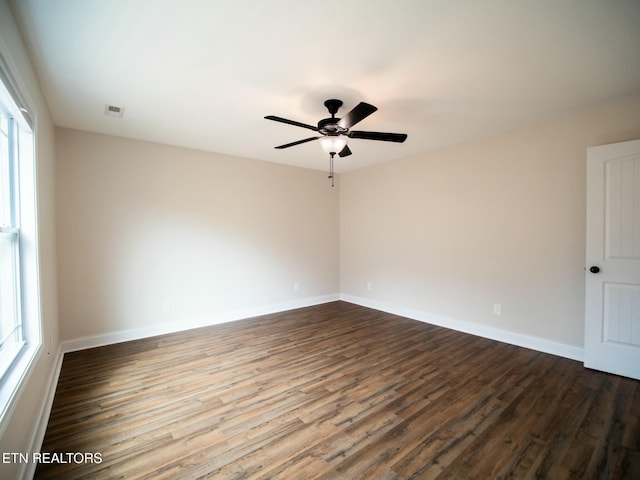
left=35, top=302, right=640, bottom=480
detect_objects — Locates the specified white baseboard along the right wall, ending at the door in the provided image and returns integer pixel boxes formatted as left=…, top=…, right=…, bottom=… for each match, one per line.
left=340, top=294, right=584, bottom=362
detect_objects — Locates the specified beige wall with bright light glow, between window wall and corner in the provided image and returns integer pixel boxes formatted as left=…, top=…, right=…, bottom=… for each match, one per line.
left=56, top=128, right=339, bottom=340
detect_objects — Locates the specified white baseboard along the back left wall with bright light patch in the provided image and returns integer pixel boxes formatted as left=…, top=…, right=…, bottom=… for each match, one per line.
left=62, top=293, right=340, bottom=353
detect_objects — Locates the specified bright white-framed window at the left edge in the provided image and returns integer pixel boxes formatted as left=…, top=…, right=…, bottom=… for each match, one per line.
left=0, top=51, right=42, bottom=428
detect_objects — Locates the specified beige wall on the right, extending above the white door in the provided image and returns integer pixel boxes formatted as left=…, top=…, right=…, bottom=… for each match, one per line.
left=340, top=97, right=640, bottom=348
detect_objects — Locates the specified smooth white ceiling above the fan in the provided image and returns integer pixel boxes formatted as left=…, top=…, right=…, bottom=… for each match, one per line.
left=8, top=0, right=640, bottom=172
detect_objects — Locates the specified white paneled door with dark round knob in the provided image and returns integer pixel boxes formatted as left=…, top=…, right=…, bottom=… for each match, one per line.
left=584, top=140, right=640, bottom=379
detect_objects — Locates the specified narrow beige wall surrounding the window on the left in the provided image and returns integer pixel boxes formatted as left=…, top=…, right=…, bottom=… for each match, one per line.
left=0, top=0, right=59, bottom=478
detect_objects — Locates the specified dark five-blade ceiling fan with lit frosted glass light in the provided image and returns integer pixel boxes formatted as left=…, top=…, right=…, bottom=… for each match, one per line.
left=264, top=99, right=407, bottom=185
